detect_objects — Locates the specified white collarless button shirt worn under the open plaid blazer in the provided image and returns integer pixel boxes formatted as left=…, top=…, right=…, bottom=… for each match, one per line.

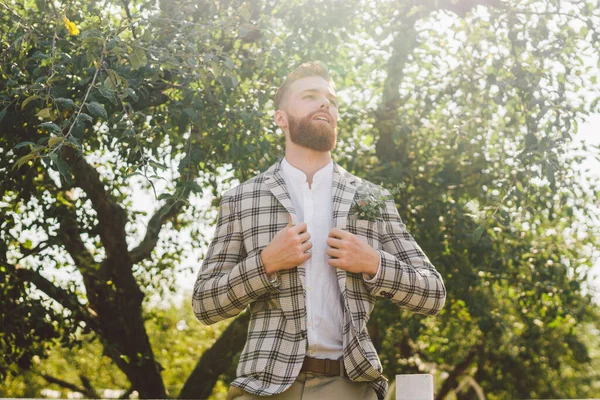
left=281, top=158, right=344, bottom=360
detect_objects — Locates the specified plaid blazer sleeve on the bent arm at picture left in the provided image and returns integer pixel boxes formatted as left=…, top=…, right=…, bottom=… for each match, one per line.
left=192, top=194, right=276, bottom=324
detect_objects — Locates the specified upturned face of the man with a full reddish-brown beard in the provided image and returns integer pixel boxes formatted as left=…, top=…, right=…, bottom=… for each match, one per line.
left=282, top=76, right=338, bottom=151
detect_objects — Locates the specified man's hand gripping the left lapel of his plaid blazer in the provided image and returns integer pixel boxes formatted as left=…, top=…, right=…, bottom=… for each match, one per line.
left=260, top=214, right=312, bottom=275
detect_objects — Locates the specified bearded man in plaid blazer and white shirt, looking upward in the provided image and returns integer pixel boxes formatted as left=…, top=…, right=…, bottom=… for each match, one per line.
left=192, top=62, right=446, bottom=400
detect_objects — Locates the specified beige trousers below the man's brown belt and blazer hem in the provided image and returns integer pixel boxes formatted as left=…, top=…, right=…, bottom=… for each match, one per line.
left=227, top=372, right=377, bottom=400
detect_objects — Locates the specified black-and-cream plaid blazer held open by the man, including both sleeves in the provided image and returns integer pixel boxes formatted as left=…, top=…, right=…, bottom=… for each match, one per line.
left=192, top=160, right=446, bottom=398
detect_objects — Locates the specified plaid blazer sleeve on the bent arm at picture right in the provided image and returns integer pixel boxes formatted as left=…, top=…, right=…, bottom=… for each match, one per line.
left=365, top=200, right=446, bottom=315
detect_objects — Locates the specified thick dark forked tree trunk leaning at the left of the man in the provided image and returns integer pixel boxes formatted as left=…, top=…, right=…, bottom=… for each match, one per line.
left=60, top=149, right=167, bottom=398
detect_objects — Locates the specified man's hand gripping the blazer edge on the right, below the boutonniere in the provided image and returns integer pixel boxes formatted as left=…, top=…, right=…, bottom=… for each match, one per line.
left=326, top=228, right=379, bottom=276
